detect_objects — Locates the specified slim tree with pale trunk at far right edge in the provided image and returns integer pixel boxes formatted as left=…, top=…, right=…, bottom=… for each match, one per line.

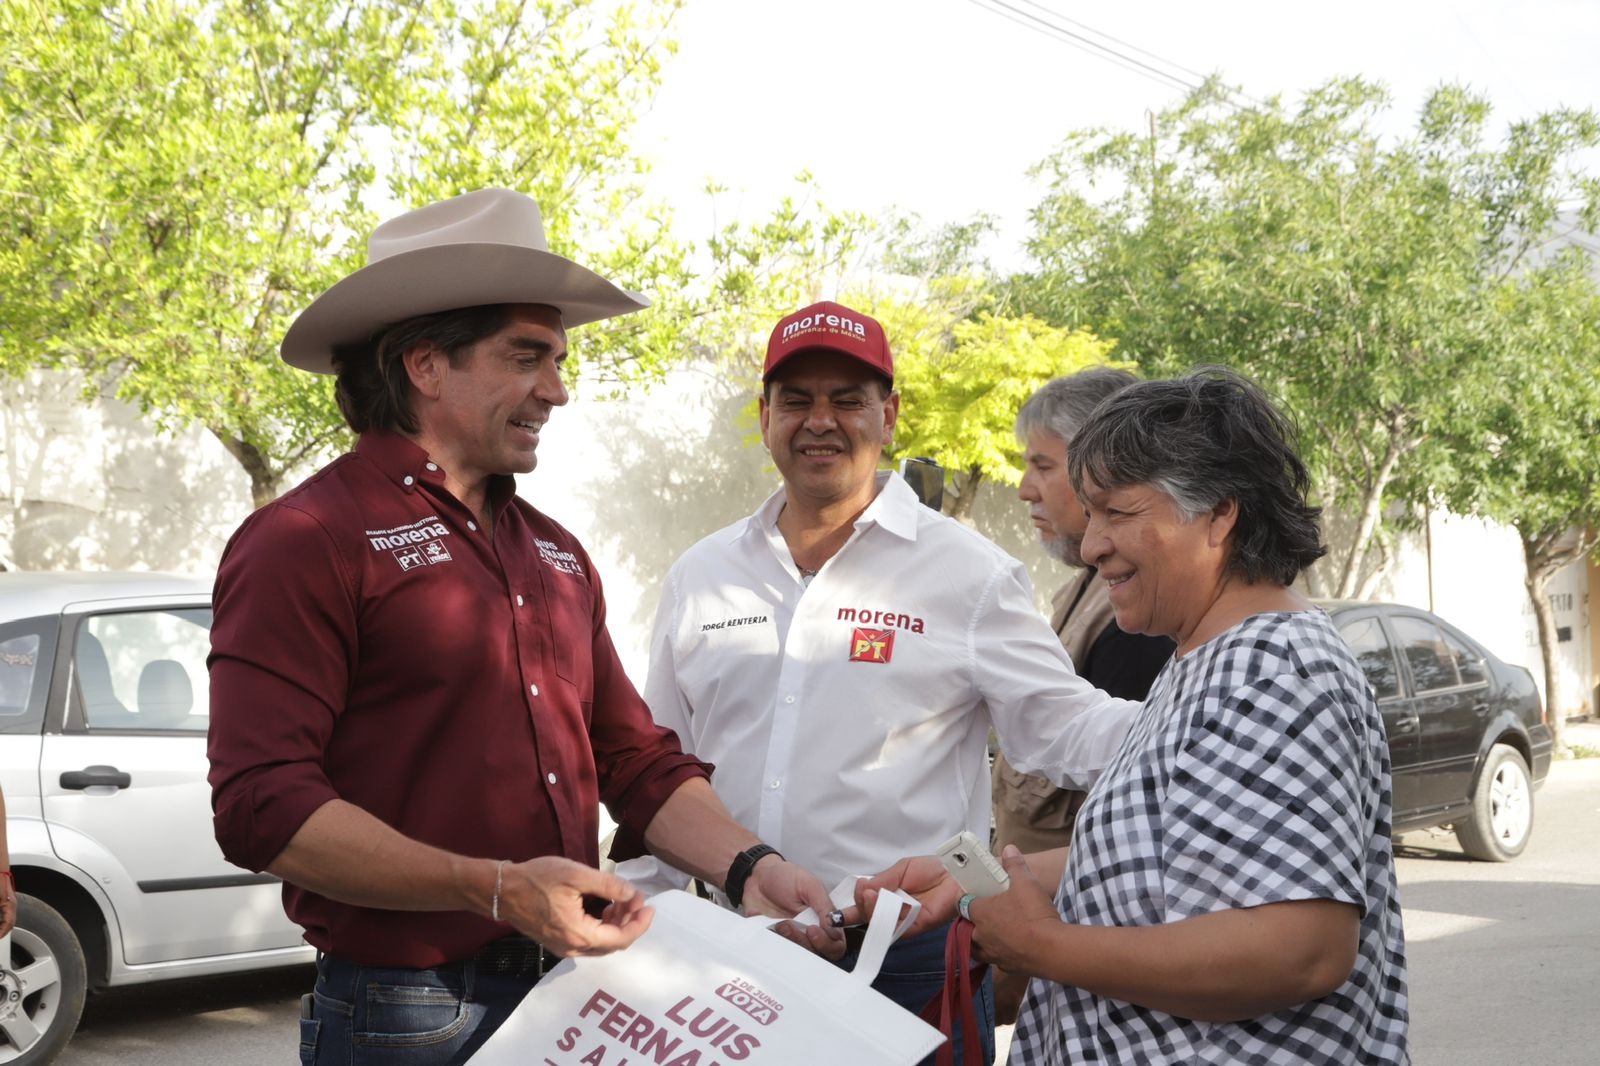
left=1434, top=238, right=1600, bottom=754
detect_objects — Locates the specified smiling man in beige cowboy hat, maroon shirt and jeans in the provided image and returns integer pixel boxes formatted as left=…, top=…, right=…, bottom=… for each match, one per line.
left=210, top=189, right=842, bottom=1063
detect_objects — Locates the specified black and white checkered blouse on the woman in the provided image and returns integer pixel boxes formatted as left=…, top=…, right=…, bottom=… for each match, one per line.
left=1011, top=611, right=1410, bottom=1066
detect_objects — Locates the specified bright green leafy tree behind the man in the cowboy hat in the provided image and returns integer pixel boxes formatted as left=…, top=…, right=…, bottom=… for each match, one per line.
left=0, top=0, right=686, bottom=504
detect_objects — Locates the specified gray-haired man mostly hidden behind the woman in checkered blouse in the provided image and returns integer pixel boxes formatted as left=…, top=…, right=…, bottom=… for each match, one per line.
left=994, top=367, right=1173, bottom=1023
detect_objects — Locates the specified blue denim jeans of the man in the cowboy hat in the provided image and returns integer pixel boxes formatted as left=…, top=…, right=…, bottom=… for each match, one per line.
left=299, top=954, right=539, bottom=1066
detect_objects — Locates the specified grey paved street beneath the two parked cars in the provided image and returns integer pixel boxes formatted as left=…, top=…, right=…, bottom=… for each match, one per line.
left=59, top=752, right=1600, bottom=1066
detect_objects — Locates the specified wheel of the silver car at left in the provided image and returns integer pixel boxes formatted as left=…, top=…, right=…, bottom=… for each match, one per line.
left=0, top=892, right=88, bottom=1066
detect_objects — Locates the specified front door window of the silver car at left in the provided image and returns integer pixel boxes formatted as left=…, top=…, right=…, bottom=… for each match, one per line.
left=72, top=608, right=211, bottom=733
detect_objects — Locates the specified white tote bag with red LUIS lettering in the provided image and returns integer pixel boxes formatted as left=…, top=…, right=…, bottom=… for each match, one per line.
left=472, top=892, right=944, bottom=1066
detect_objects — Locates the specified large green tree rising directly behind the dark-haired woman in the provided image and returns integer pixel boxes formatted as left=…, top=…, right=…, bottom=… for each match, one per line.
left=1018, top=80, right=1597, bottom=597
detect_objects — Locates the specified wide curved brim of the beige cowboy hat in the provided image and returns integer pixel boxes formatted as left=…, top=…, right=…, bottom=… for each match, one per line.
left=278, top=243, right=650, bottom=375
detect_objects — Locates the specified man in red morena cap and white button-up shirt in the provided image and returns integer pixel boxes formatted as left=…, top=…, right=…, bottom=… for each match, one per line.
left=619, top=303, right=1136, bottom=1061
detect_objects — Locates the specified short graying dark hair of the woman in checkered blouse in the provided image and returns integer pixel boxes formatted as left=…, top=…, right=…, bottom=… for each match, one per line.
left=1067, top=367, right=1328, bottom=584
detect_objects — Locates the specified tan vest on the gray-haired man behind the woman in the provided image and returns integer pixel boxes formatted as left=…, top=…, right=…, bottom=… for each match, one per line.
left=992, top=568, right=1115, bottom=853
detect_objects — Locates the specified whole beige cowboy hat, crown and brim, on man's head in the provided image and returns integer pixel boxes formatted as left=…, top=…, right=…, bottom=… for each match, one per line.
left=280, top=189, right=650, bottom=375
